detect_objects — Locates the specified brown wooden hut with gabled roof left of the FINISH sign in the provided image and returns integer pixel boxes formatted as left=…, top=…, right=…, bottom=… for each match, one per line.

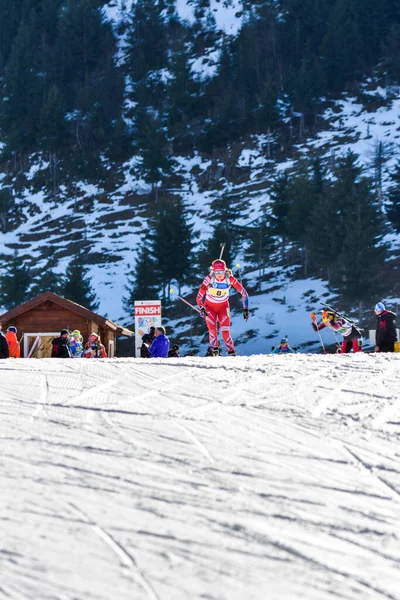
left=0, top=292, right=133, bottom=358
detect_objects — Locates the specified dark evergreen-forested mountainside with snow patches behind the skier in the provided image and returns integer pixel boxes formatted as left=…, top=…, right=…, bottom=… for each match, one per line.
left=0, top=0, right=400, bottom=328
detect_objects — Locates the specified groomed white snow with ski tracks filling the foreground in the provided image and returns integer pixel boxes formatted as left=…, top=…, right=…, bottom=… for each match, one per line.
left=0, top=354, right=400, bottom=600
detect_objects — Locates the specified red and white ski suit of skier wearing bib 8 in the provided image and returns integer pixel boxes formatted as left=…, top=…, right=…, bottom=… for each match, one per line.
left=196, top=271, right=249, bottom=354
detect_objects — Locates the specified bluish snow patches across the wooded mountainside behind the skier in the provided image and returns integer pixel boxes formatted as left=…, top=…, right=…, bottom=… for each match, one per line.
left=0, top=0, right=400, bottom=355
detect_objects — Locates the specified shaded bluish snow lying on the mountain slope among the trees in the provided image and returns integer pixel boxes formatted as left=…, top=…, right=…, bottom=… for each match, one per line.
left=0, top=0, right=400, bottom=354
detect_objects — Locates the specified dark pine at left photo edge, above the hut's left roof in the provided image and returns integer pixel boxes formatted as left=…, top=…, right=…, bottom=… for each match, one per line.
left=0, top=251, right=32, bottom=310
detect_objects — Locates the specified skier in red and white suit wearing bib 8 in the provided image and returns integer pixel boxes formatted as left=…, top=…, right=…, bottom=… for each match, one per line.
left=196, top=259, right=249, bottom=356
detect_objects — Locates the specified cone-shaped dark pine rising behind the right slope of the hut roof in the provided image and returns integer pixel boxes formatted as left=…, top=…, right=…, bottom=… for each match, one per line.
left=60, top=254, right=99, bottom=311
